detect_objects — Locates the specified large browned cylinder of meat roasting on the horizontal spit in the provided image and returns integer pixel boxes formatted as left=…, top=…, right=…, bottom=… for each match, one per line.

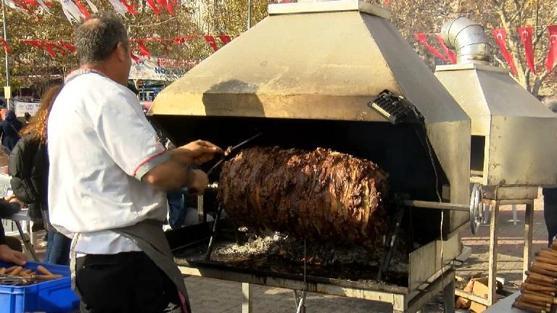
left=219, top=147, right=387, bottom=244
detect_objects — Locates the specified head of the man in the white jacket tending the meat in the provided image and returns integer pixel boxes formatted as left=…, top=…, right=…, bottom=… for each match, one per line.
left=75, top=14, right=131, bottom=85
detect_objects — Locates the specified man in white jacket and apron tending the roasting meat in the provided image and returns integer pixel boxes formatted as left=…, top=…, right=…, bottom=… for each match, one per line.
left=48, top=15, right=222, bottom=313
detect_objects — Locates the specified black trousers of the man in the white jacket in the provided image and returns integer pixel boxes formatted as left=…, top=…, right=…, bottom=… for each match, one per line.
left=76, top=252, right=179, bottom=313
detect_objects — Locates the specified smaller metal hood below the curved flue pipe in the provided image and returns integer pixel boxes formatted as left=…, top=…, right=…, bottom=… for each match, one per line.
left=435, top=58, right=557, bottom=186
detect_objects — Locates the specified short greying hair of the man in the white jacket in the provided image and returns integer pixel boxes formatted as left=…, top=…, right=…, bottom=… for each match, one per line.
left=75, top=13, right=129, bottom=65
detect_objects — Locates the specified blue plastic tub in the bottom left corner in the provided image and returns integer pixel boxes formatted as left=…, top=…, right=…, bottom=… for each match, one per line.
left=0, top=262, right=79, bottom=313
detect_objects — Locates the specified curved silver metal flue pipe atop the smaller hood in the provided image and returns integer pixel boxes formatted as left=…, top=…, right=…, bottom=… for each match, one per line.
left=441, top=16, right=490, bottom=64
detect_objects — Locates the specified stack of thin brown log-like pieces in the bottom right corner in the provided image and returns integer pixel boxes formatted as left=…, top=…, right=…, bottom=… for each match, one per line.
left=513, top=243, right=557, bottom=313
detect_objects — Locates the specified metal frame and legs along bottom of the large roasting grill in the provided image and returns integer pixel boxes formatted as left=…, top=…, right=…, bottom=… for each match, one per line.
left=178, top=266, right=455, bottom=313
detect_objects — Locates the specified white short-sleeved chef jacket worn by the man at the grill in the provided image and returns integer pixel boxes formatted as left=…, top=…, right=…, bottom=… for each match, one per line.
left=48, top=72, right=167, bottom=254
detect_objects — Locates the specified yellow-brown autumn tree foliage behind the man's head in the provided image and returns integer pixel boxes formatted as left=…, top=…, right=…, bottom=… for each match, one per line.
left=0, top=0, right=207, bottom=91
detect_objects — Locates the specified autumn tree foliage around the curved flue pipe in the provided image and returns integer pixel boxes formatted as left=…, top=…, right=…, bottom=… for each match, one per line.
left=389, top=0, right=557, bottom=96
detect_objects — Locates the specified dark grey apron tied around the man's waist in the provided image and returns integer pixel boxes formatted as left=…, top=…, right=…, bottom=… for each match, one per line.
left=70, top=220, right=191, bottom=313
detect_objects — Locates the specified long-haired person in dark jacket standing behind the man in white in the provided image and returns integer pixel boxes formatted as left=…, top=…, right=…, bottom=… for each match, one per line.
left=8, top=84, right=71, bottom=265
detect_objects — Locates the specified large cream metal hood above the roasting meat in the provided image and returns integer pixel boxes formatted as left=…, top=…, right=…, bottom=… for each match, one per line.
left=151, top=0, right=468, bottom=124
